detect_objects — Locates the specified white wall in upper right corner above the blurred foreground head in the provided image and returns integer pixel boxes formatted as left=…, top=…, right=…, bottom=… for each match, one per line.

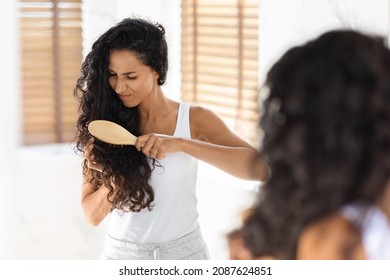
left=259, top=0, right=389, bottom=84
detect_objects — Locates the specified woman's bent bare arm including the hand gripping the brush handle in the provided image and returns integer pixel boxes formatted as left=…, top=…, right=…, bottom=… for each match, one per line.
left=136, top=106, right=270, bottom=181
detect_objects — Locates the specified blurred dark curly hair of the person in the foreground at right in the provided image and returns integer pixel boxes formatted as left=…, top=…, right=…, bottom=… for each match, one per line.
left=254, top=30, right=390, bottom=256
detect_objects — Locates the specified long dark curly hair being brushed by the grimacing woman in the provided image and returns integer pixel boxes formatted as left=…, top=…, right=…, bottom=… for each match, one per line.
left=74, top=18, right=168, bottom=211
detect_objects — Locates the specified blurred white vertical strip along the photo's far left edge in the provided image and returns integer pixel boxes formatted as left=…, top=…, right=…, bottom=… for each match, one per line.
left=0, top=0, right=21, bottom=259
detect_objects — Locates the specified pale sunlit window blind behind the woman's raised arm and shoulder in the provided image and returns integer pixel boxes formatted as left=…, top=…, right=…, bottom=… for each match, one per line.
left=181, top=0, right=259, bottom=146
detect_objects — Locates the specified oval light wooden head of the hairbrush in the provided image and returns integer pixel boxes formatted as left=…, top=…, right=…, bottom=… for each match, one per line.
left=88, top=120, right=137, bottom=146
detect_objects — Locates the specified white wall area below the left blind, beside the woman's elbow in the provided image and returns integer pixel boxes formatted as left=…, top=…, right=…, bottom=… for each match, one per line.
left=17, top=144, right=104, bottom=259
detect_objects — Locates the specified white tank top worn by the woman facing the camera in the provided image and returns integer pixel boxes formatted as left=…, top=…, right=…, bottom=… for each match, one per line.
left=108, top=103, right=198, bottom=243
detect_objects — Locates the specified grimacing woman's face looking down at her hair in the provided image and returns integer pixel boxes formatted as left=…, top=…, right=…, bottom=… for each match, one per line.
left=108, top=50, right=158, bottom=107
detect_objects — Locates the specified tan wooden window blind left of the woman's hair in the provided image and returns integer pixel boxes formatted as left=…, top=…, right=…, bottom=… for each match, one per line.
left=18, top=0, right=82, bottom=145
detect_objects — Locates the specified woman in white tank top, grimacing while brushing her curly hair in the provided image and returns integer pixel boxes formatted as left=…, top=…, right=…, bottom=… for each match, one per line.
left=75, top=18, right=268, bottom=259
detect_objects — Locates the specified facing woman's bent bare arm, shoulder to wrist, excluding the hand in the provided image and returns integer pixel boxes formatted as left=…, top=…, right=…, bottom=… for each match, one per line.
left=182, top=106, right=269, bottom=181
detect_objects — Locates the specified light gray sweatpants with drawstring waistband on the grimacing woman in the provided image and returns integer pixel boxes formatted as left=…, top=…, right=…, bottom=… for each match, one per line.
left=102, top=228, right=209, bottom=260
